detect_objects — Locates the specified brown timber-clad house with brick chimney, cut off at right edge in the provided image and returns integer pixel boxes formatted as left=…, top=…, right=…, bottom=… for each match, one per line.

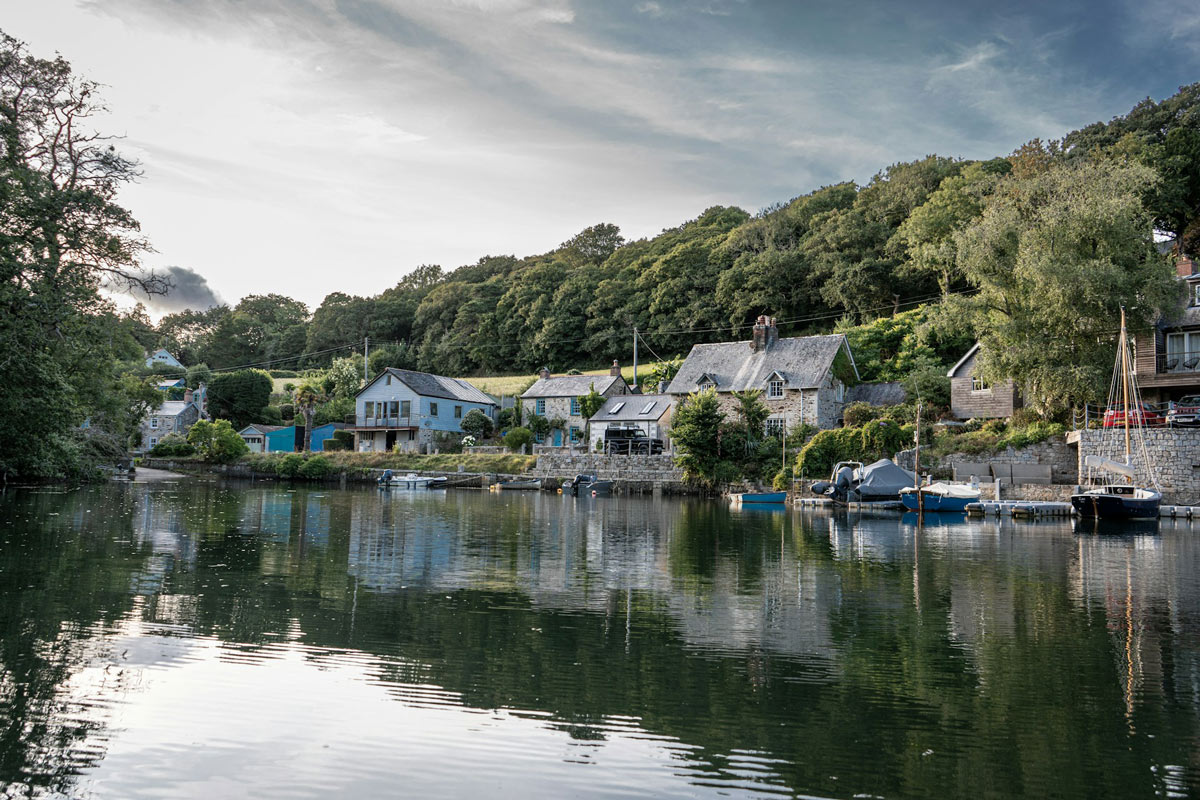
left=1134, top=255, right=1200, bottom=403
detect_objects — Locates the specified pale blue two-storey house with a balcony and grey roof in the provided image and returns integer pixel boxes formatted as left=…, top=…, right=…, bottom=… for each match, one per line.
left=350, top=367, right=496, bottom=452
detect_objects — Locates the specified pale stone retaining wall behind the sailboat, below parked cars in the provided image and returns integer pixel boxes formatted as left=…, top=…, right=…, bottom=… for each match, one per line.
left=1078, top=428, right=1200, bottom=499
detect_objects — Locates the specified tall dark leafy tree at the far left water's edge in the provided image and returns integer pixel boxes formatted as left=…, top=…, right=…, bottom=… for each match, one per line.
left=0, top=32, right=168, bottom=477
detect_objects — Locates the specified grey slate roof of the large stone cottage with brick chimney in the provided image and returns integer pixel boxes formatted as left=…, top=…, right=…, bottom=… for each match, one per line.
left=667, top=333, right=858, bottom=395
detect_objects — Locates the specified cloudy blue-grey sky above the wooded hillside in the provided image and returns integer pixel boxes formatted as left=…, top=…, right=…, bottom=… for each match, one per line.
left=0, top=0, right=1200, bottom=313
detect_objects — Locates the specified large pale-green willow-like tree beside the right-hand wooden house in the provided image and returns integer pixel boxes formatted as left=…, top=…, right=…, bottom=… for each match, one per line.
left=955, top=162, right=1180, bottom=411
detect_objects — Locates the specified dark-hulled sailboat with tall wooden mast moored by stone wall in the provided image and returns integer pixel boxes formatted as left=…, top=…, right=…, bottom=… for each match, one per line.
left=1070, top=306, right=1163, bottom=519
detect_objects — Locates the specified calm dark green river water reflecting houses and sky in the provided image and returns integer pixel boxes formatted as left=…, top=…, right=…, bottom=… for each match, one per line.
left=0, top=481, right=1200, bottom=799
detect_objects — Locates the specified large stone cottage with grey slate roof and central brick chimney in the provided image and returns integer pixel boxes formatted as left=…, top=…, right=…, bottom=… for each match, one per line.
left=667, top=317, right=858, bottom=432
